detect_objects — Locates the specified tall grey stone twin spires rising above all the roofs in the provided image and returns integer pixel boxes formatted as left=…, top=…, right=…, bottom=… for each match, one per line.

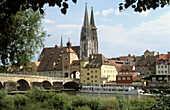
left=80, top=3, right=98, bottom=60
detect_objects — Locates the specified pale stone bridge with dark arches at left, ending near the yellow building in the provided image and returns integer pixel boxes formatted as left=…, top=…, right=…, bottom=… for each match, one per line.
left=0, top=74, right=79, bottom=91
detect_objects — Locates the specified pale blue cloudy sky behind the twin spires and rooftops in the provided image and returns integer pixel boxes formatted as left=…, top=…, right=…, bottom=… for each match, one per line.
left=34, top=0, right=170, bottom=58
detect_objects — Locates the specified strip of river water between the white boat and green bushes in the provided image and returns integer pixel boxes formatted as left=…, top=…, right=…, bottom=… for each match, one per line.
left=61, top=91, right=154, bottom=100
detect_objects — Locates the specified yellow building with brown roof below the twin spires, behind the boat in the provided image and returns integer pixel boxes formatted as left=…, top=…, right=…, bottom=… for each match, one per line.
left=80, top=54, right=118, bottom=84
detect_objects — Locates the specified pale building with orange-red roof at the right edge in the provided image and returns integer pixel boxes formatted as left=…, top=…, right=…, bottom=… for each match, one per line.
left=156, top=52, right=170, bottom=75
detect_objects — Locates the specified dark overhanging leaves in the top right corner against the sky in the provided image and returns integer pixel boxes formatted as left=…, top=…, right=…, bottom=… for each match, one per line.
left=119, top=0, right=170, bottom=12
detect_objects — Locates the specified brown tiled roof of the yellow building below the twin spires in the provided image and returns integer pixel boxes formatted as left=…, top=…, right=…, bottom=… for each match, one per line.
left=85, top=54, right=114, bottom=68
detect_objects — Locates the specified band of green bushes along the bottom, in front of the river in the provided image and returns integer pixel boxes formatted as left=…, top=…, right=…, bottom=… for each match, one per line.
left=0, top=88, right=170, bottom=110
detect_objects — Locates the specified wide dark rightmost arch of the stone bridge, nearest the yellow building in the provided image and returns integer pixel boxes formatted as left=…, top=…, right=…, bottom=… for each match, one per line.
left=63, top=81, right=79, bottom=90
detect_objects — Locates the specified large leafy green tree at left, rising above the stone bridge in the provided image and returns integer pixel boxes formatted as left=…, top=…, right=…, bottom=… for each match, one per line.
left=0, top=9, right=47, bottom=71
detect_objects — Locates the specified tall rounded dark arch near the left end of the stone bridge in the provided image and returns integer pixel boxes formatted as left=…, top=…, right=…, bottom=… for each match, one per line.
left=17, top=79, right=30, bottom=91
